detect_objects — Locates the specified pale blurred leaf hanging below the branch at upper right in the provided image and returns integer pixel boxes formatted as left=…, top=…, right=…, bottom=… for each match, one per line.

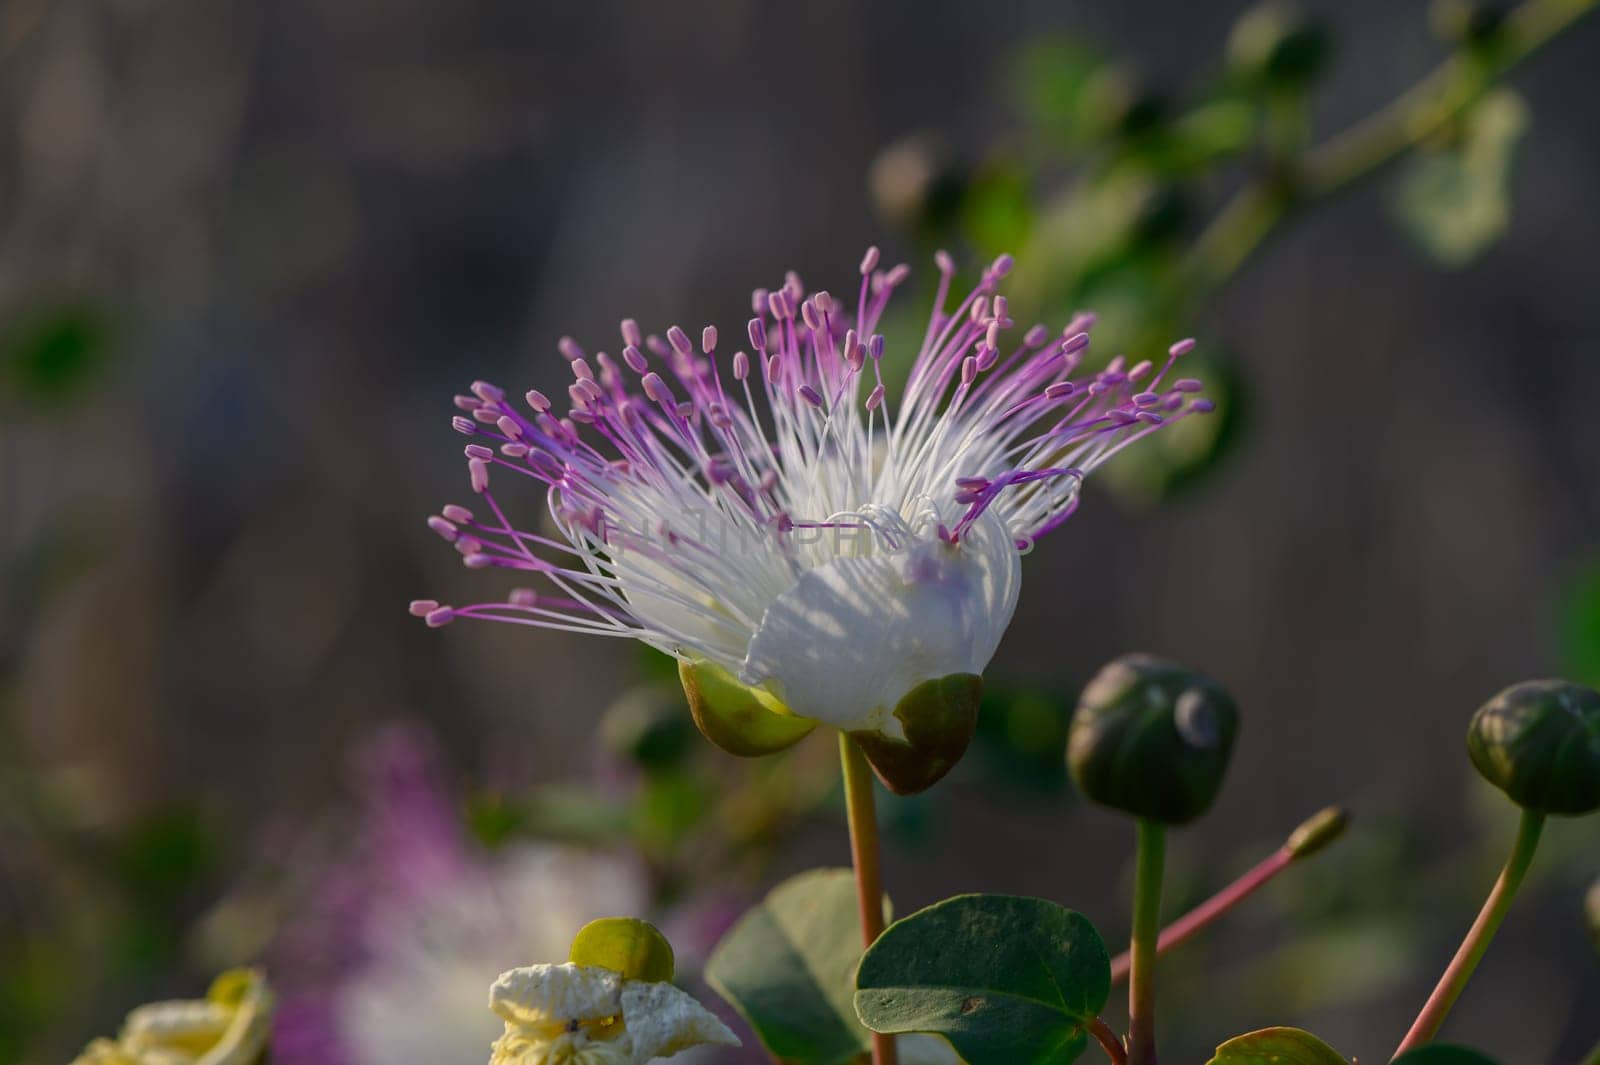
left=1394, top=90, right=1528, bottom=265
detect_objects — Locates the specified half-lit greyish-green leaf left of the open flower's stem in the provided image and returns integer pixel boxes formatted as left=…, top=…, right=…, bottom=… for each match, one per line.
left=706, top=868, right=886, bottom=1065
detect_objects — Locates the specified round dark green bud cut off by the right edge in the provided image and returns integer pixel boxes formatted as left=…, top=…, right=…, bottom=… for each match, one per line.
left=1467, top=680, right=1600, bottom=814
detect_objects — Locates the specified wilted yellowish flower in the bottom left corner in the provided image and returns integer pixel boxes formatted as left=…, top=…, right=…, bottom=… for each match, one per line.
left=74, top=969, right=272, bottom=1065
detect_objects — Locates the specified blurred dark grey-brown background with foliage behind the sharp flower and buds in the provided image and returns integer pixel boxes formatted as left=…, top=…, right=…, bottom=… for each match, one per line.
left=9, top=0, right=1600, bottom=1065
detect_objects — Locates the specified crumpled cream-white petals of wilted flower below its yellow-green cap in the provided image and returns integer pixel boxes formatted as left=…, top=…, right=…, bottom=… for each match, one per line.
left=490, top=963, right=739, bottom=1065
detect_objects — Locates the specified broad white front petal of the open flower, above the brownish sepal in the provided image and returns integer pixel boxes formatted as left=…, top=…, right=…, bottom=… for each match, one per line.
left=739, top=513, right=1021, bottom=737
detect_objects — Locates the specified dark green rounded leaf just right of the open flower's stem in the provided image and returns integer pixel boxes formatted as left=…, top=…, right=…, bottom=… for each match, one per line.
left=856, top=895, right=1110, bottom=1065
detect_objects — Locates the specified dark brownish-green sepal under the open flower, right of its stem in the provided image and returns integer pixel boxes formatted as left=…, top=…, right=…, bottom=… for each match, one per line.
left=850, top=673, right=984, bottom=795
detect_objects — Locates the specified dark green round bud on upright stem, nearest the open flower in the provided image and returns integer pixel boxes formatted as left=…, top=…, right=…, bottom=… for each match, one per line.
left=1067, top=654, right=1238, bottom=825
